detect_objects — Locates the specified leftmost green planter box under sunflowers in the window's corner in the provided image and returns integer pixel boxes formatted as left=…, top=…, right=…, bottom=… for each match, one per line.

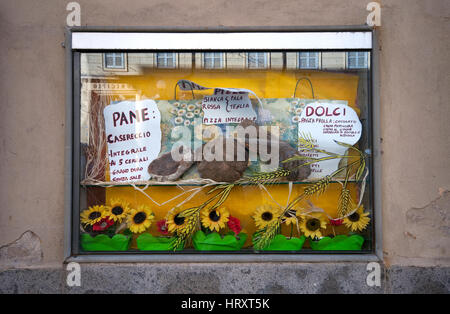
left=80, top=233, right=131, bottom=251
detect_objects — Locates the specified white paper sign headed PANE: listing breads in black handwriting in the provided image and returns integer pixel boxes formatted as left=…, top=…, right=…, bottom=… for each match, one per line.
left=103, top=100, right=161, bottom=182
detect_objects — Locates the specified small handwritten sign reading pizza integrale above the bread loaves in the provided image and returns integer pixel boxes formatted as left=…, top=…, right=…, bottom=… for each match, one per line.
left=202, top=88, right=256, bottom=124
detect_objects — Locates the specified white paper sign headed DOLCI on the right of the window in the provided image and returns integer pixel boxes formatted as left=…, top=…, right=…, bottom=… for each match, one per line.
left=298, top=103, right=362, bottom=179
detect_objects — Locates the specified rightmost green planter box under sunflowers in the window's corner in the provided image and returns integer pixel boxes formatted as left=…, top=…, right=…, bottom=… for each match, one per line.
left=309, top=234, right=364, bottom=251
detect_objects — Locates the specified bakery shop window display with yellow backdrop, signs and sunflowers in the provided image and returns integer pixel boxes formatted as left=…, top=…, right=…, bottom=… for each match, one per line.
left=68, top=31, right=379, bottom=260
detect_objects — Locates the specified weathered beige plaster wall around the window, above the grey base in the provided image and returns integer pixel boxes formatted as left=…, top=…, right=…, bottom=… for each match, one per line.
left=0, top=0, right=450, bottom=268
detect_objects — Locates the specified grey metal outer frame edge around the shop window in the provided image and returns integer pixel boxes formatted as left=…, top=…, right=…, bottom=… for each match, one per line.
left=63, top=25, right=383, bottom=263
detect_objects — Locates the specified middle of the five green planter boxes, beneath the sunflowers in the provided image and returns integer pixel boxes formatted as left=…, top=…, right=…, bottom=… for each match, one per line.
left=192, top=230, right=247, bottom=251
